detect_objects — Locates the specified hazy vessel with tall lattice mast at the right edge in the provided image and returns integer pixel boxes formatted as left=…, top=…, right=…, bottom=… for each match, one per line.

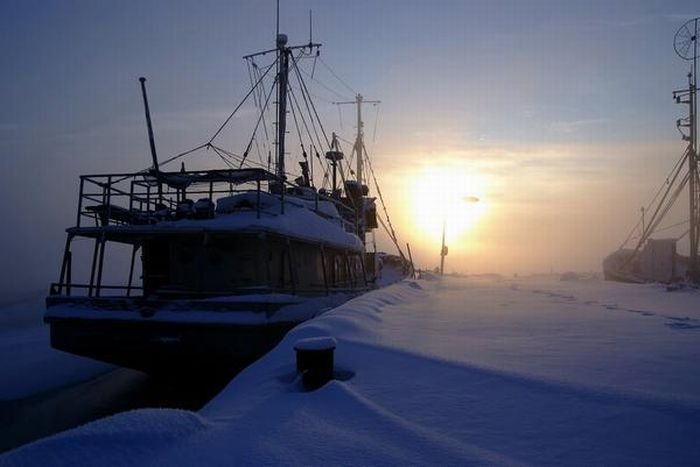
left=603, top=18, right=700, bottom=283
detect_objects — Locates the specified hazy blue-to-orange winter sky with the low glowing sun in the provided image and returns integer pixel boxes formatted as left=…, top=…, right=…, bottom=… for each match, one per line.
left=0, top=0, right=700, bottom=299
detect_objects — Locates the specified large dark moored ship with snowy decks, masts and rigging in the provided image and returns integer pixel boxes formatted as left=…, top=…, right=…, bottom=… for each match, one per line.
left=45, top=26, right=403, bottom=373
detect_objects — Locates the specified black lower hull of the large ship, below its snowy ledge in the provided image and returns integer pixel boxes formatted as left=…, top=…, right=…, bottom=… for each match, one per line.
left=49, top=318, right=298, bottom=374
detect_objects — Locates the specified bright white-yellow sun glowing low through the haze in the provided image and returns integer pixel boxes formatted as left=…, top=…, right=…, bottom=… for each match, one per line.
left=410, top=167, right=487, bottom=244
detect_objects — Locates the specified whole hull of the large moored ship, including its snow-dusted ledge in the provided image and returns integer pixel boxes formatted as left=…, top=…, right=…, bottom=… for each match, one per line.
left=44, top=290, right=364, bottom=376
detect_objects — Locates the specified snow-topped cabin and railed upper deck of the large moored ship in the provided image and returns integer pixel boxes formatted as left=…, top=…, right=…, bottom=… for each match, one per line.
left=47, top=169, right=371, bottom=306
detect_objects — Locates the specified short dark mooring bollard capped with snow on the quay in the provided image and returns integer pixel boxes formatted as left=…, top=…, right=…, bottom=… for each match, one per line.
left=294, top=337, right=337, bottom=389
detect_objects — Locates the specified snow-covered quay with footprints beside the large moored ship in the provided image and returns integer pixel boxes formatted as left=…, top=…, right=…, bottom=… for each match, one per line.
left=0, top=278, right=700, bottom=466
